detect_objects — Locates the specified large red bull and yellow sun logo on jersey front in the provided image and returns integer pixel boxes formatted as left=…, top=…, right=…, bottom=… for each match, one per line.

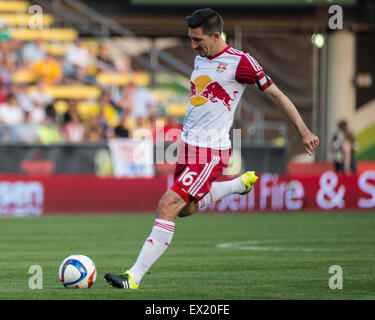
left=190, top=75, right=238, bottom=111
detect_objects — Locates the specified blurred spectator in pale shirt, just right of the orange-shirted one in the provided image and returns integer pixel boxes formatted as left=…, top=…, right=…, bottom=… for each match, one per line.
left=64, top=39, right=90, bottom=80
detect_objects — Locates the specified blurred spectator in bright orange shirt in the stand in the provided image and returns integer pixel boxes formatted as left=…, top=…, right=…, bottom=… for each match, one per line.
left=32, top=53, right=63, bottom=85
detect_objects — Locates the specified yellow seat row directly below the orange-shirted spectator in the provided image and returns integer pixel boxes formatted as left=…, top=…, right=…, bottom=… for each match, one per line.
left=29, top=85, right=101, bottom=99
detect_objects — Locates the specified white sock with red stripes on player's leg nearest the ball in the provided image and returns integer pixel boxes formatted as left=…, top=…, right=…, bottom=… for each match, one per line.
left=129, top=219, right=174, bottom=283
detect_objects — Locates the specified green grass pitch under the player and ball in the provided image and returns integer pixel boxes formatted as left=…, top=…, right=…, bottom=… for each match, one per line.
left=0, top=212, right=375, bottom=300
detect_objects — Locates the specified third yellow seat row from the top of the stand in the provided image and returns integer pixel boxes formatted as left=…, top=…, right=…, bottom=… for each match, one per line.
left=9, top=28, right=78, bottom=41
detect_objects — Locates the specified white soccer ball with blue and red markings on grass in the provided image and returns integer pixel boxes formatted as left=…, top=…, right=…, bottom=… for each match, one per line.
left=59, top=254, right=96, bottom=289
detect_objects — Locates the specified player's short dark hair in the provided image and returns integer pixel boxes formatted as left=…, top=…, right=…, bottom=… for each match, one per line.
left=186, top=8, right=223, bottom=35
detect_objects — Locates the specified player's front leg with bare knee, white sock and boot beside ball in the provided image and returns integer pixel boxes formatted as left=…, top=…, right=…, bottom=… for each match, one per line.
left=104, top=190, right=187, bottom=289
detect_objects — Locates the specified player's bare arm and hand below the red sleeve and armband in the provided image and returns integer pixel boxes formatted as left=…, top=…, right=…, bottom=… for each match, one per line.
left=263, top=83, right=319, bottom=156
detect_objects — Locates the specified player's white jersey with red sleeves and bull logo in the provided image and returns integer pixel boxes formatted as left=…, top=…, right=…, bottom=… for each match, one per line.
left=182, top=46, right=272, bottom=150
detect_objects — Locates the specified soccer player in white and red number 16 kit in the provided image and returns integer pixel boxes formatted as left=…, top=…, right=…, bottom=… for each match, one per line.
left=104, top=8, right=319, bottom=289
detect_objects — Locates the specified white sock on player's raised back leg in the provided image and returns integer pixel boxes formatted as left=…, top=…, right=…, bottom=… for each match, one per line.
left=198, top=177, right=246, bottom=208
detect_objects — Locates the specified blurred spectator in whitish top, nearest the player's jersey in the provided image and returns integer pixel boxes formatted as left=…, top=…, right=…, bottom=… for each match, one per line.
left=114, top=82, right=158, bottom=119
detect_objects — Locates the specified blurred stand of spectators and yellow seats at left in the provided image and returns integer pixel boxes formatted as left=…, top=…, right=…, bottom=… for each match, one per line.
left=0, top=1, right=186, bottom=144
